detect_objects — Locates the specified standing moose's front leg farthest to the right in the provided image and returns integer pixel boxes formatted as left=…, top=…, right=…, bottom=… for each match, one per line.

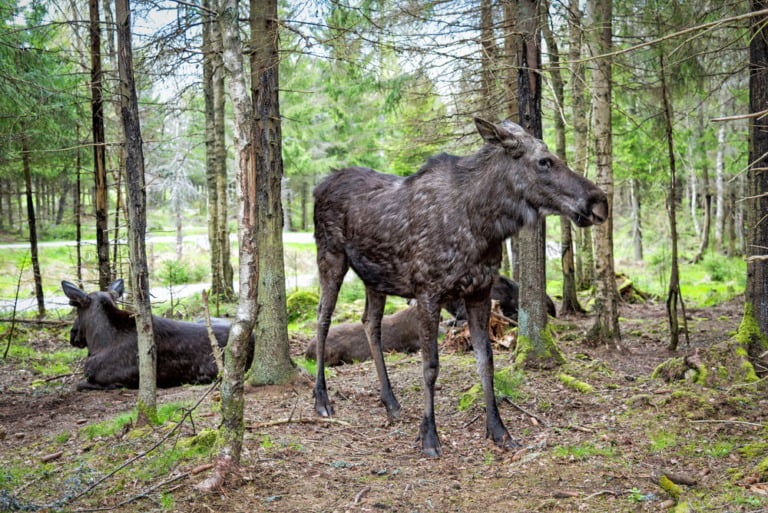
left=465, top=296, right=519, bottom=448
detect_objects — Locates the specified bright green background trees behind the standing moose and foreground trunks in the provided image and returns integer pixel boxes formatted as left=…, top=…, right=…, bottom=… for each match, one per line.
left=0, top=1, right=749, bottom=304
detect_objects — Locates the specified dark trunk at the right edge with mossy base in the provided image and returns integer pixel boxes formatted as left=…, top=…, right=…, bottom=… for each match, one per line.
left=742, top=0, right=768, bottom=344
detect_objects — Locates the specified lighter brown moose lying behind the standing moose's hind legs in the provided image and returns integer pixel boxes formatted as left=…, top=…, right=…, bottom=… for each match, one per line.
left=305, top=306, right=421, bottom=365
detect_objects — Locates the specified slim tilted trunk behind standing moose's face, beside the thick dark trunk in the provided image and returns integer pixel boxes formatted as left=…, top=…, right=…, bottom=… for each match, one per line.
left=541, top=0, right=585, bottom=313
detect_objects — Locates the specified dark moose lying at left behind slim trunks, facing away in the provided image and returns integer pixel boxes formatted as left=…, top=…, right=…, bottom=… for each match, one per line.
left=61, top=280, right=253, bottom=390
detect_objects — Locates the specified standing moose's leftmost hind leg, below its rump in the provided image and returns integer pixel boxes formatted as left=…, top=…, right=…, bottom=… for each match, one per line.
left=314, top=248, right=349, bottom=417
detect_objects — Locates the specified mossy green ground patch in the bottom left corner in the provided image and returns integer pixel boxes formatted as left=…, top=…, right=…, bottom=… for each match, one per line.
left=0, top=401, right=220, bottom=511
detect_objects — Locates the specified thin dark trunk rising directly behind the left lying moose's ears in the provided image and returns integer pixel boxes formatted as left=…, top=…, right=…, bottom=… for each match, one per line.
left=88, top=0, right=111, bottom=290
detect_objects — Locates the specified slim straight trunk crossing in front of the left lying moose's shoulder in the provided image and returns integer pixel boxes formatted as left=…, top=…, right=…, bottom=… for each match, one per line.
left=115, top=0, right=157, bottom=426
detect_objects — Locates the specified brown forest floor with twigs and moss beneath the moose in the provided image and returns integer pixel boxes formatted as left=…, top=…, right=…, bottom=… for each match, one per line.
left=0, top=299, right=768, bottom=513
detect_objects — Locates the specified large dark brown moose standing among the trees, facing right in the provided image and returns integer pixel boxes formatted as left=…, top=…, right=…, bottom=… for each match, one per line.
left=314, top=118, right=608, bottom=457
